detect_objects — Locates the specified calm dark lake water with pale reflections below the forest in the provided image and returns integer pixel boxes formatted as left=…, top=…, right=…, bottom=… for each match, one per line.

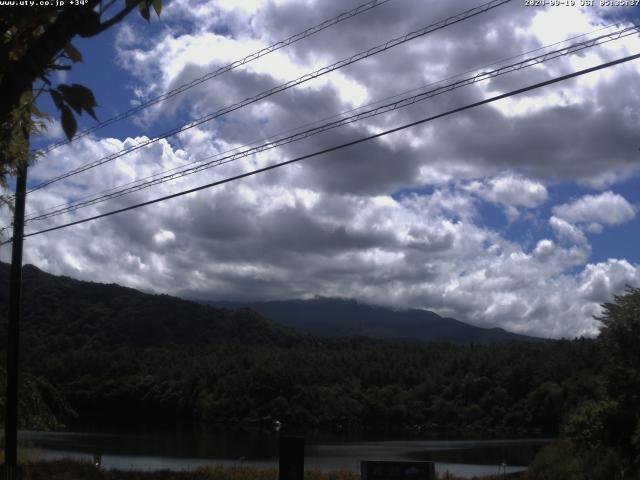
left=19, top=427, right=550, bottom=477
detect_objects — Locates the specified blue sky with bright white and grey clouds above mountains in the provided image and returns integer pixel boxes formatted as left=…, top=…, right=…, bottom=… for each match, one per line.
left=0, top=0, right=640, bottom=338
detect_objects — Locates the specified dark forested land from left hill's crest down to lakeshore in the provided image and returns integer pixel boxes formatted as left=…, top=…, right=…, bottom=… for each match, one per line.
left=0, top=265, right=600, bottom=435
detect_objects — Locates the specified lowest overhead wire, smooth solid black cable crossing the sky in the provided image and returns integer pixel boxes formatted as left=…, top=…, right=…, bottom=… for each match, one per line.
left=7, top=53, right=640, bottom=245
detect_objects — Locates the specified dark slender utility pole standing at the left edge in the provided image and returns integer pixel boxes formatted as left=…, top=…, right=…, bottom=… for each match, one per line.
left=4, top=162, right=27, bottom=472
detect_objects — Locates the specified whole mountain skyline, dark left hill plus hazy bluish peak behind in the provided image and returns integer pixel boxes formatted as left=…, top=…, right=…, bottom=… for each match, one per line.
left=0, top=263, right=539, bottom=351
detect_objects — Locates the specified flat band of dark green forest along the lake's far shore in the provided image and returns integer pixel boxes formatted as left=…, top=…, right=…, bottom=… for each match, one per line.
left=18, top=339, right=597, bottom=435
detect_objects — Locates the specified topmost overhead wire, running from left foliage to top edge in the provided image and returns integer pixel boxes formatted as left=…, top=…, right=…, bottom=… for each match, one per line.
left=38, top=0, right=391, bottom=154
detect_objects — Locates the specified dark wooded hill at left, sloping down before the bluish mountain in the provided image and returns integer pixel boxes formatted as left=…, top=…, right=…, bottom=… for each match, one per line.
left=0, top=263, right=299, bottom=351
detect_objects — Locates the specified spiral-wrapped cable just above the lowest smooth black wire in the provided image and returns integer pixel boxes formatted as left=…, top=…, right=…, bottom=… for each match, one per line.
left=22, top=26, right=638, bottom=221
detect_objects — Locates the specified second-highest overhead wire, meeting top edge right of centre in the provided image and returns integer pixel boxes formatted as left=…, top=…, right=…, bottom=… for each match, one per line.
left=27, top=0, right=512, bottom=193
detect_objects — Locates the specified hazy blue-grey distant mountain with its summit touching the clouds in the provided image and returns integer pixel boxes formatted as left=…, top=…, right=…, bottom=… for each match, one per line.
left=210, top=298, right=539, bottom=344
